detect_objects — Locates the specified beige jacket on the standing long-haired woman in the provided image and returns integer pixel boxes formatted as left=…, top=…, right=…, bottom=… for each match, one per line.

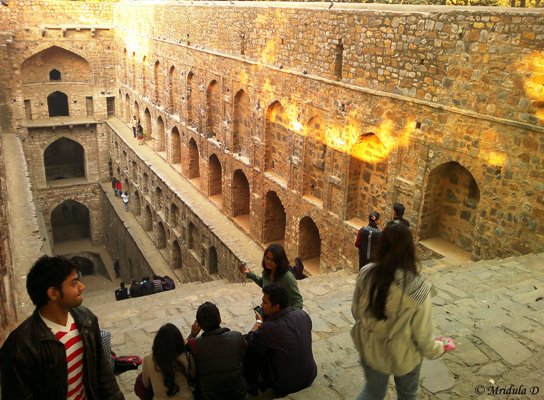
left=351, top=264, right=444, bottom=376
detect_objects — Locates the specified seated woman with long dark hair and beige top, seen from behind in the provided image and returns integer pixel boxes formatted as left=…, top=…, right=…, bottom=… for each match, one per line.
left=142, top=323, right=195, bottom=400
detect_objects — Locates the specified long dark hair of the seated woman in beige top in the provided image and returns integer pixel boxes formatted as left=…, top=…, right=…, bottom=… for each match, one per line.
left=153, top=323, right=187, bottom=397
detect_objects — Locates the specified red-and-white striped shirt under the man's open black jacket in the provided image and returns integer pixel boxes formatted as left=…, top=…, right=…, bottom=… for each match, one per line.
left=40, top=313, right=87, bottom=400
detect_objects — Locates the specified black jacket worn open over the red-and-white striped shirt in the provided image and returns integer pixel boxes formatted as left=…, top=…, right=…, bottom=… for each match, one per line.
left=0, top=306, right=125, bottom=400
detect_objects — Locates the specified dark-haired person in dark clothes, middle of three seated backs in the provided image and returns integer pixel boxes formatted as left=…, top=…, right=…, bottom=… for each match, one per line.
left=187, top=301, right=247, bottom=400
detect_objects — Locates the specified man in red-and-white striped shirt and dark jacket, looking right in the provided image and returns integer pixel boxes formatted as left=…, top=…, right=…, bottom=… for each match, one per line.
left=0, top=256, right=124, bottom=400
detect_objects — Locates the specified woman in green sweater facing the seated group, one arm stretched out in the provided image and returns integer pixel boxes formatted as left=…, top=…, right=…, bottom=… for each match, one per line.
left=239, top=244, right=302, bottom=310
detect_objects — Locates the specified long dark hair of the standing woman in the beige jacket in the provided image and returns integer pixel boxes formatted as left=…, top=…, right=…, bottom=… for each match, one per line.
left=367, top=224, right=418, bottom=320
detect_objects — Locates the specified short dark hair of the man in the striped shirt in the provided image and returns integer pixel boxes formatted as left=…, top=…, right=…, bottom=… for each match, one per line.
left=26, top=256, right=77, bottom=307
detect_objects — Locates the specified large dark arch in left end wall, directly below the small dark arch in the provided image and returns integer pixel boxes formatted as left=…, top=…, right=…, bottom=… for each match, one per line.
left=43, top=136, right=85, bottom=181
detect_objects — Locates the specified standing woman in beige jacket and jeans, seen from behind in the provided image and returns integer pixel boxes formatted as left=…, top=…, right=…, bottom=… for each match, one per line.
left=351, top=224, right=455, bottom=400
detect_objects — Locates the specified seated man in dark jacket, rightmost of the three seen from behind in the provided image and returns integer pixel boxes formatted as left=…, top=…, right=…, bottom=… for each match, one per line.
left=244, top=283, right=317, bottom=397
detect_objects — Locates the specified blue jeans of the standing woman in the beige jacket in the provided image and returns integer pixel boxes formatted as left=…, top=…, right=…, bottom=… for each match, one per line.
left=357, top=363, right=421, bottom=400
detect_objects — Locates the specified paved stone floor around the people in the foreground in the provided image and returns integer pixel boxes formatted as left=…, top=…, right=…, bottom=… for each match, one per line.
left=84, top=254, right=544, bottom=400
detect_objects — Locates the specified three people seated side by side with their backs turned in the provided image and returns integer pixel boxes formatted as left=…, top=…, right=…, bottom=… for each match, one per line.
left=137, top=284, right=317, bottom=400
